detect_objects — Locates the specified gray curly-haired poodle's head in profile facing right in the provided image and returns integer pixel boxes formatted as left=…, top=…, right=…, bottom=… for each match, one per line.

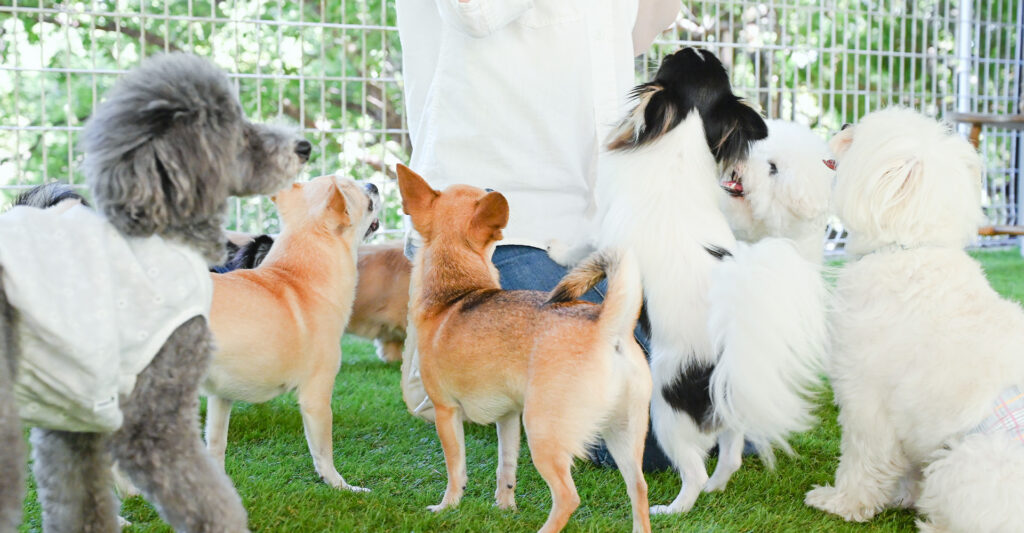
left=82, top=53, right=312, bottom=262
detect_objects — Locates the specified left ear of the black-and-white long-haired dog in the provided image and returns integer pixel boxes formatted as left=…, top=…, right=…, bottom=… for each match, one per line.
left=607, top=82, right=684, bottom=150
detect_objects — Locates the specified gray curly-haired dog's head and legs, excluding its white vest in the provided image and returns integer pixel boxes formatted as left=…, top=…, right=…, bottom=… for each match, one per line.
left=0, top=54, right=311, bottom=532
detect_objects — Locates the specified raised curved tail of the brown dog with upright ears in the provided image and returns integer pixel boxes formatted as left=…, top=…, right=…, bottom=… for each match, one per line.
left=547, top=250, right=643, bottom=337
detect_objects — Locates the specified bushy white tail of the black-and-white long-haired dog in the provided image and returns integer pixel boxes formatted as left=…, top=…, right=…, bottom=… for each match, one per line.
left=709, top=238, right=828, bottom=465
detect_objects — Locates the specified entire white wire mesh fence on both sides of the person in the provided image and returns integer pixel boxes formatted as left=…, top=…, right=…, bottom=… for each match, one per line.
left=0, top=0, right=1024, bottom=250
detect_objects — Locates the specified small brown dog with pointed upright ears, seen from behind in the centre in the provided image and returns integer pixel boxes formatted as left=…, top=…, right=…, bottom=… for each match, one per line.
left=397, top=165, right=651, bottom=532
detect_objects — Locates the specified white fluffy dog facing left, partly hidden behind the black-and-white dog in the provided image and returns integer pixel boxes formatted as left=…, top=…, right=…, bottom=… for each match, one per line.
left=722, top=120, right=836, bottom=263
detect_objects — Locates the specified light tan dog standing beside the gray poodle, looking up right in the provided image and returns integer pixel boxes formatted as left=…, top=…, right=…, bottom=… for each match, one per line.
left=197, top=176, right=381, bottom=490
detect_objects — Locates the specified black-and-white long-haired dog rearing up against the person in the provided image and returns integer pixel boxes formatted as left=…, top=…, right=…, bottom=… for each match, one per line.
left=552, top=48, right=826, bottom=514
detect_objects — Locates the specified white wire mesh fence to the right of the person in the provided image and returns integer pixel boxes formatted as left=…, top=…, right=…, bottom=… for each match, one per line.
left=638, top=0, right=1024, bottom=251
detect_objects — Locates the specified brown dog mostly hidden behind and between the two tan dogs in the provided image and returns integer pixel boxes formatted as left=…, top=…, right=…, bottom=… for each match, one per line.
left=345, top=240, right=413, bottom=363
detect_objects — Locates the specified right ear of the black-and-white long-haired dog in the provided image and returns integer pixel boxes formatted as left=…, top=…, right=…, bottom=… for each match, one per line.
left=702, top=96, right=768, bottom=166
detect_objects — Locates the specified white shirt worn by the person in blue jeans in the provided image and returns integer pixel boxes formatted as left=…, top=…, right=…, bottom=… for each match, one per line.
left=397, top=0, right=680, bottom=248
